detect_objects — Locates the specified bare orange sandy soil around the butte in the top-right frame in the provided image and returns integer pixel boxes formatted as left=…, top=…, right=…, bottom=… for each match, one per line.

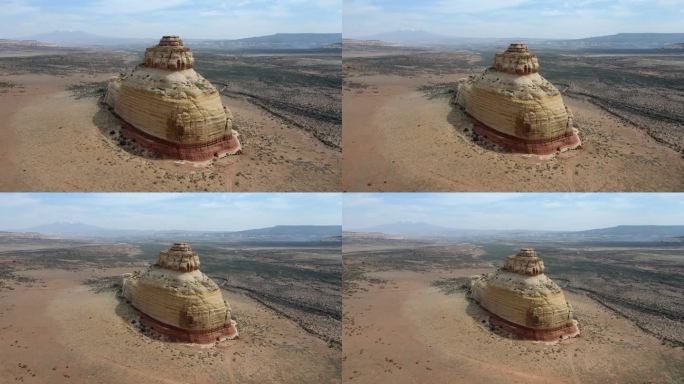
left=342, top=73, right=684, bottom=192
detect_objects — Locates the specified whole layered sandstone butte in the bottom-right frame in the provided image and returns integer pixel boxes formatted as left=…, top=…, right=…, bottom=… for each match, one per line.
left=470, top=248, right=579, bottom=341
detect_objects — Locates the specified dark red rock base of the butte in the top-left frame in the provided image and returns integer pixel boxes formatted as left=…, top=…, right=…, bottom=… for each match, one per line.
left=117, top=116, right=242, bottom=161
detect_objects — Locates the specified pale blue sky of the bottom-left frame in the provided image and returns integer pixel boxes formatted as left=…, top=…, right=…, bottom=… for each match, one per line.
left=0, top=193, right=342, bottom=231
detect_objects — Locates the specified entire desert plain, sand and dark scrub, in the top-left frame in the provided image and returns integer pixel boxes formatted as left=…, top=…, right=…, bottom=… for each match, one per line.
left=0, top=49, right=341, bottom=191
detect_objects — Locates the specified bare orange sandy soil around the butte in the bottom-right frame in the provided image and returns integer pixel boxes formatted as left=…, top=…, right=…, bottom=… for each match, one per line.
left=342, top=269, right=684, bottom=383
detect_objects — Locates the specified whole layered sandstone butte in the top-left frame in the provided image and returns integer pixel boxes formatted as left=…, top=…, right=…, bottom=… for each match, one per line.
left=104, top=36, right=241, bottom=161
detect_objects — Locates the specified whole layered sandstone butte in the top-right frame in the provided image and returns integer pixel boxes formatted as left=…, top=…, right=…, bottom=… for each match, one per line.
left=455, top=44, right=581, bottom=155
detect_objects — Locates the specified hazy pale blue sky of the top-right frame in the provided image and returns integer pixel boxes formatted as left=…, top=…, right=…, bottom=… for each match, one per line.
left=344, top=0, right=684, bottom=38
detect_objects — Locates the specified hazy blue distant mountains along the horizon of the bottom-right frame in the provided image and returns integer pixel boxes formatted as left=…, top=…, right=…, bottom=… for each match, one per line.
left=352, top=222, right=684, bottom=241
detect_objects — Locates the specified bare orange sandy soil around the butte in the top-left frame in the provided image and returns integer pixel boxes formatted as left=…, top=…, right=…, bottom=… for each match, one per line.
left=0, top=74, right=341, bottom=191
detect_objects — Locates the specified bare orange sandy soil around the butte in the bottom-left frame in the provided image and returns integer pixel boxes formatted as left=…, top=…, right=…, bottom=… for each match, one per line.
left=0, top=269, right=340, bottom=384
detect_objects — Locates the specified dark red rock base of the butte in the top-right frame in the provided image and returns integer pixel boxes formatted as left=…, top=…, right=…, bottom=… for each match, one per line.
left=471, top=117, right=582, bottom=155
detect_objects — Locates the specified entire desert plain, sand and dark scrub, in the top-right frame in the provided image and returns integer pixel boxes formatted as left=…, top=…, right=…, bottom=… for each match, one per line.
left=342, top=46, right=684, bottom=191
